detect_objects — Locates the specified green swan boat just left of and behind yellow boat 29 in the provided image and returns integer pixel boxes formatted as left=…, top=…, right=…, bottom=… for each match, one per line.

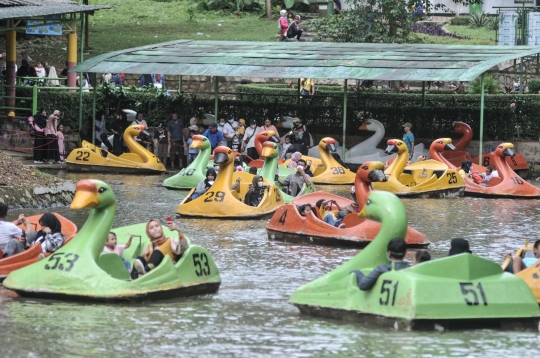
left=162, top=135, right=212, bottom=189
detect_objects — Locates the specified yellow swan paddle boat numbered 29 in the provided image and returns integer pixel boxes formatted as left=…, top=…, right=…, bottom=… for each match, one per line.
left=176, top=146, right=283, bottom=219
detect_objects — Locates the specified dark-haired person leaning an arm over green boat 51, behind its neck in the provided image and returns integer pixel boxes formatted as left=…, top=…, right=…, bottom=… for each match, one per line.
left=351, top=238, right=410, bottom=291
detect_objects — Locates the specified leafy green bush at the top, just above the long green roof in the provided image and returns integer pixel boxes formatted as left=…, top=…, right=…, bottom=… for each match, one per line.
left=310, top=0, right=420, bottom=43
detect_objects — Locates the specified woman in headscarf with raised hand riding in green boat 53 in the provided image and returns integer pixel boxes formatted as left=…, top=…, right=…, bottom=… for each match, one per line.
left=131, top=219, right=189, bottom=279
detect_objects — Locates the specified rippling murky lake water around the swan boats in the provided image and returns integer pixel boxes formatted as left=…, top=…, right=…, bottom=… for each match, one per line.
left=0, top=173, right=540, bottom=357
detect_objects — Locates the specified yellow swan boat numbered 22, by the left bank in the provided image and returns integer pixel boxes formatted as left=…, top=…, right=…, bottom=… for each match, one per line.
left=66, top=124, right=165, bottom=174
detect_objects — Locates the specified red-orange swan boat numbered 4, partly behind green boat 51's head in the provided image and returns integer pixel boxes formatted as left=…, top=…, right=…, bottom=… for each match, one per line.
left=266, top=162, right=430, bottom=247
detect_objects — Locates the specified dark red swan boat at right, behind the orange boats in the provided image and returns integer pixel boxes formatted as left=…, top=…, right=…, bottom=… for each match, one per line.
left=442, top=122, right=529, bottom=178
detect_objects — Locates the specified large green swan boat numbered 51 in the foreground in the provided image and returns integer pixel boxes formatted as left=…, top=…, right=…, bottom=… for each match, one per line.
left=290, top=191, right=540, bottom=330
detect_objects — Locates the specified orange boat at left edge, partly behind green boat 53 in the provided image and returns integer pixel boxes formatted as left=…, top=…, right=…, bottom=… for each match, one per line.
left=0, top=213, right=77, bottom=281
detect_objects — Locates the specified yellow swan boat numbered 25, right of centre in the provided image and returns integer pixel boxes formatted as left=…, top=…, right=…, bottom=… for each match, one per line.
left=372, top=139, right=465, bottom=198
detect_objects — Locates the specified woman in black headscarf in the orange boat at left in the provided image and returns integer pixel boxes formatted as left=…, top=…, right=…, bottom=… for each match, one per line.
left=26, top=213, right=66, bottom=259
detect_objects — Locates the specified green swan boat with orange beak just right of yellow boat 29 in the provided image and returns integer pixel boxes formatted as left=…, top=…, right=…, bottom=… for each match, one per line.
left=259, top=141, right=315, bottom=204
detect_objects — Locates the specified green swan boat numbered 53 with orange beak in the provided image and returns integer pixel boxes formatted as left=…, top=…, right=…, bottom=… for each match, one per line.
left=4, top=180, right=221, bottom=301
